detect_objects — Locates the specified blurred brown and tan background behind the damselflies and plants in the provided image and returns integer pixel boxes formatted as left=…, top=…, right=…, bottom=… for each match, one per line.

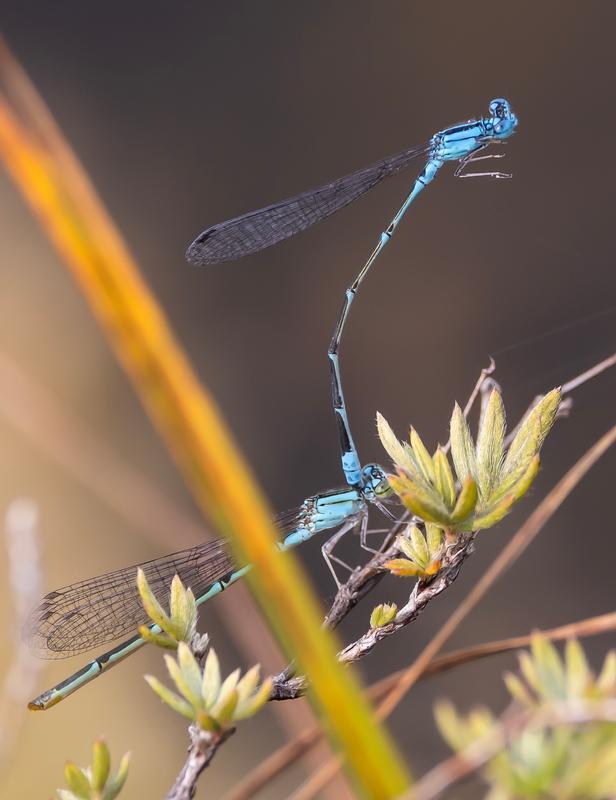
left=0, top=0, right=616, bottom=800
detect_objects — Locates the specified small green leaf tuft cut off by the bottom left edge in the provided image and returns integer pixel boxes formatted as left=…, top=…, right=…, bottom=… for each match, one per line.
left=56, top=739, right=130, bottom=800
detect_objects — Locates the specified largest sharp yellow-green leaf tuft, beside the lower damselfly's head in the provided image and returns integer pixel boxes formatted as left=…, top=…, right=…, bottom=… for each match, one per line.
left=377, top=389, right=560, bottom=536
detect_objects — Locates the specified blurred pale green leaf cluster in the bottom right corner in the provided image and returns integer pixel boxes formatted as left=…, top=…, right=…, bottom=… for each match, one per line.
left=435, top=635, right=616, bottom=800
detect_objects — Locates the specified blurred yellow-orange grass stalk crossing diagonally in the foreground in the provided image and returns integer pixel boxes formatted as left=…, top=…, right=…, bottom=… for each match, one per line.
left=0, top=56, right=410, bottom=798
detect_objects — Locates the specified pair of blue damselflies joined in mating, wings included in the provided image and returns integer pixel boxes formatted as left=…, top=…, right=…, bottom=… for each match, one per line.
left=26, top=99, right=517, bottom=710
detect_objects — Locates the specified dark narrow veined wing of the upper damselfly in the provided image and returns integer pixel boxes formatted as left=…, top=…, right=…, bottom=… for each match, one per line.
left=186, top=144, right=430, bottom=264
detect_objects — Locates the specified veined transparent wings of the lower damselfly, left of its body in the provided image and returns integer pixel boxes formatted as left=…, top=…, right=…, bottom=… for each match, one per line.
left=23, top=509, right=308, bottom=659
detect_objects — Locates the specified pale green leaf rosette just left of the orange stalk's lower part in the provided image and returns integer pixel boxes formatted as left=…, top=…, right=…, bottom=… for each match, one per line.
left=145, top=642, right=272, bottom=733
